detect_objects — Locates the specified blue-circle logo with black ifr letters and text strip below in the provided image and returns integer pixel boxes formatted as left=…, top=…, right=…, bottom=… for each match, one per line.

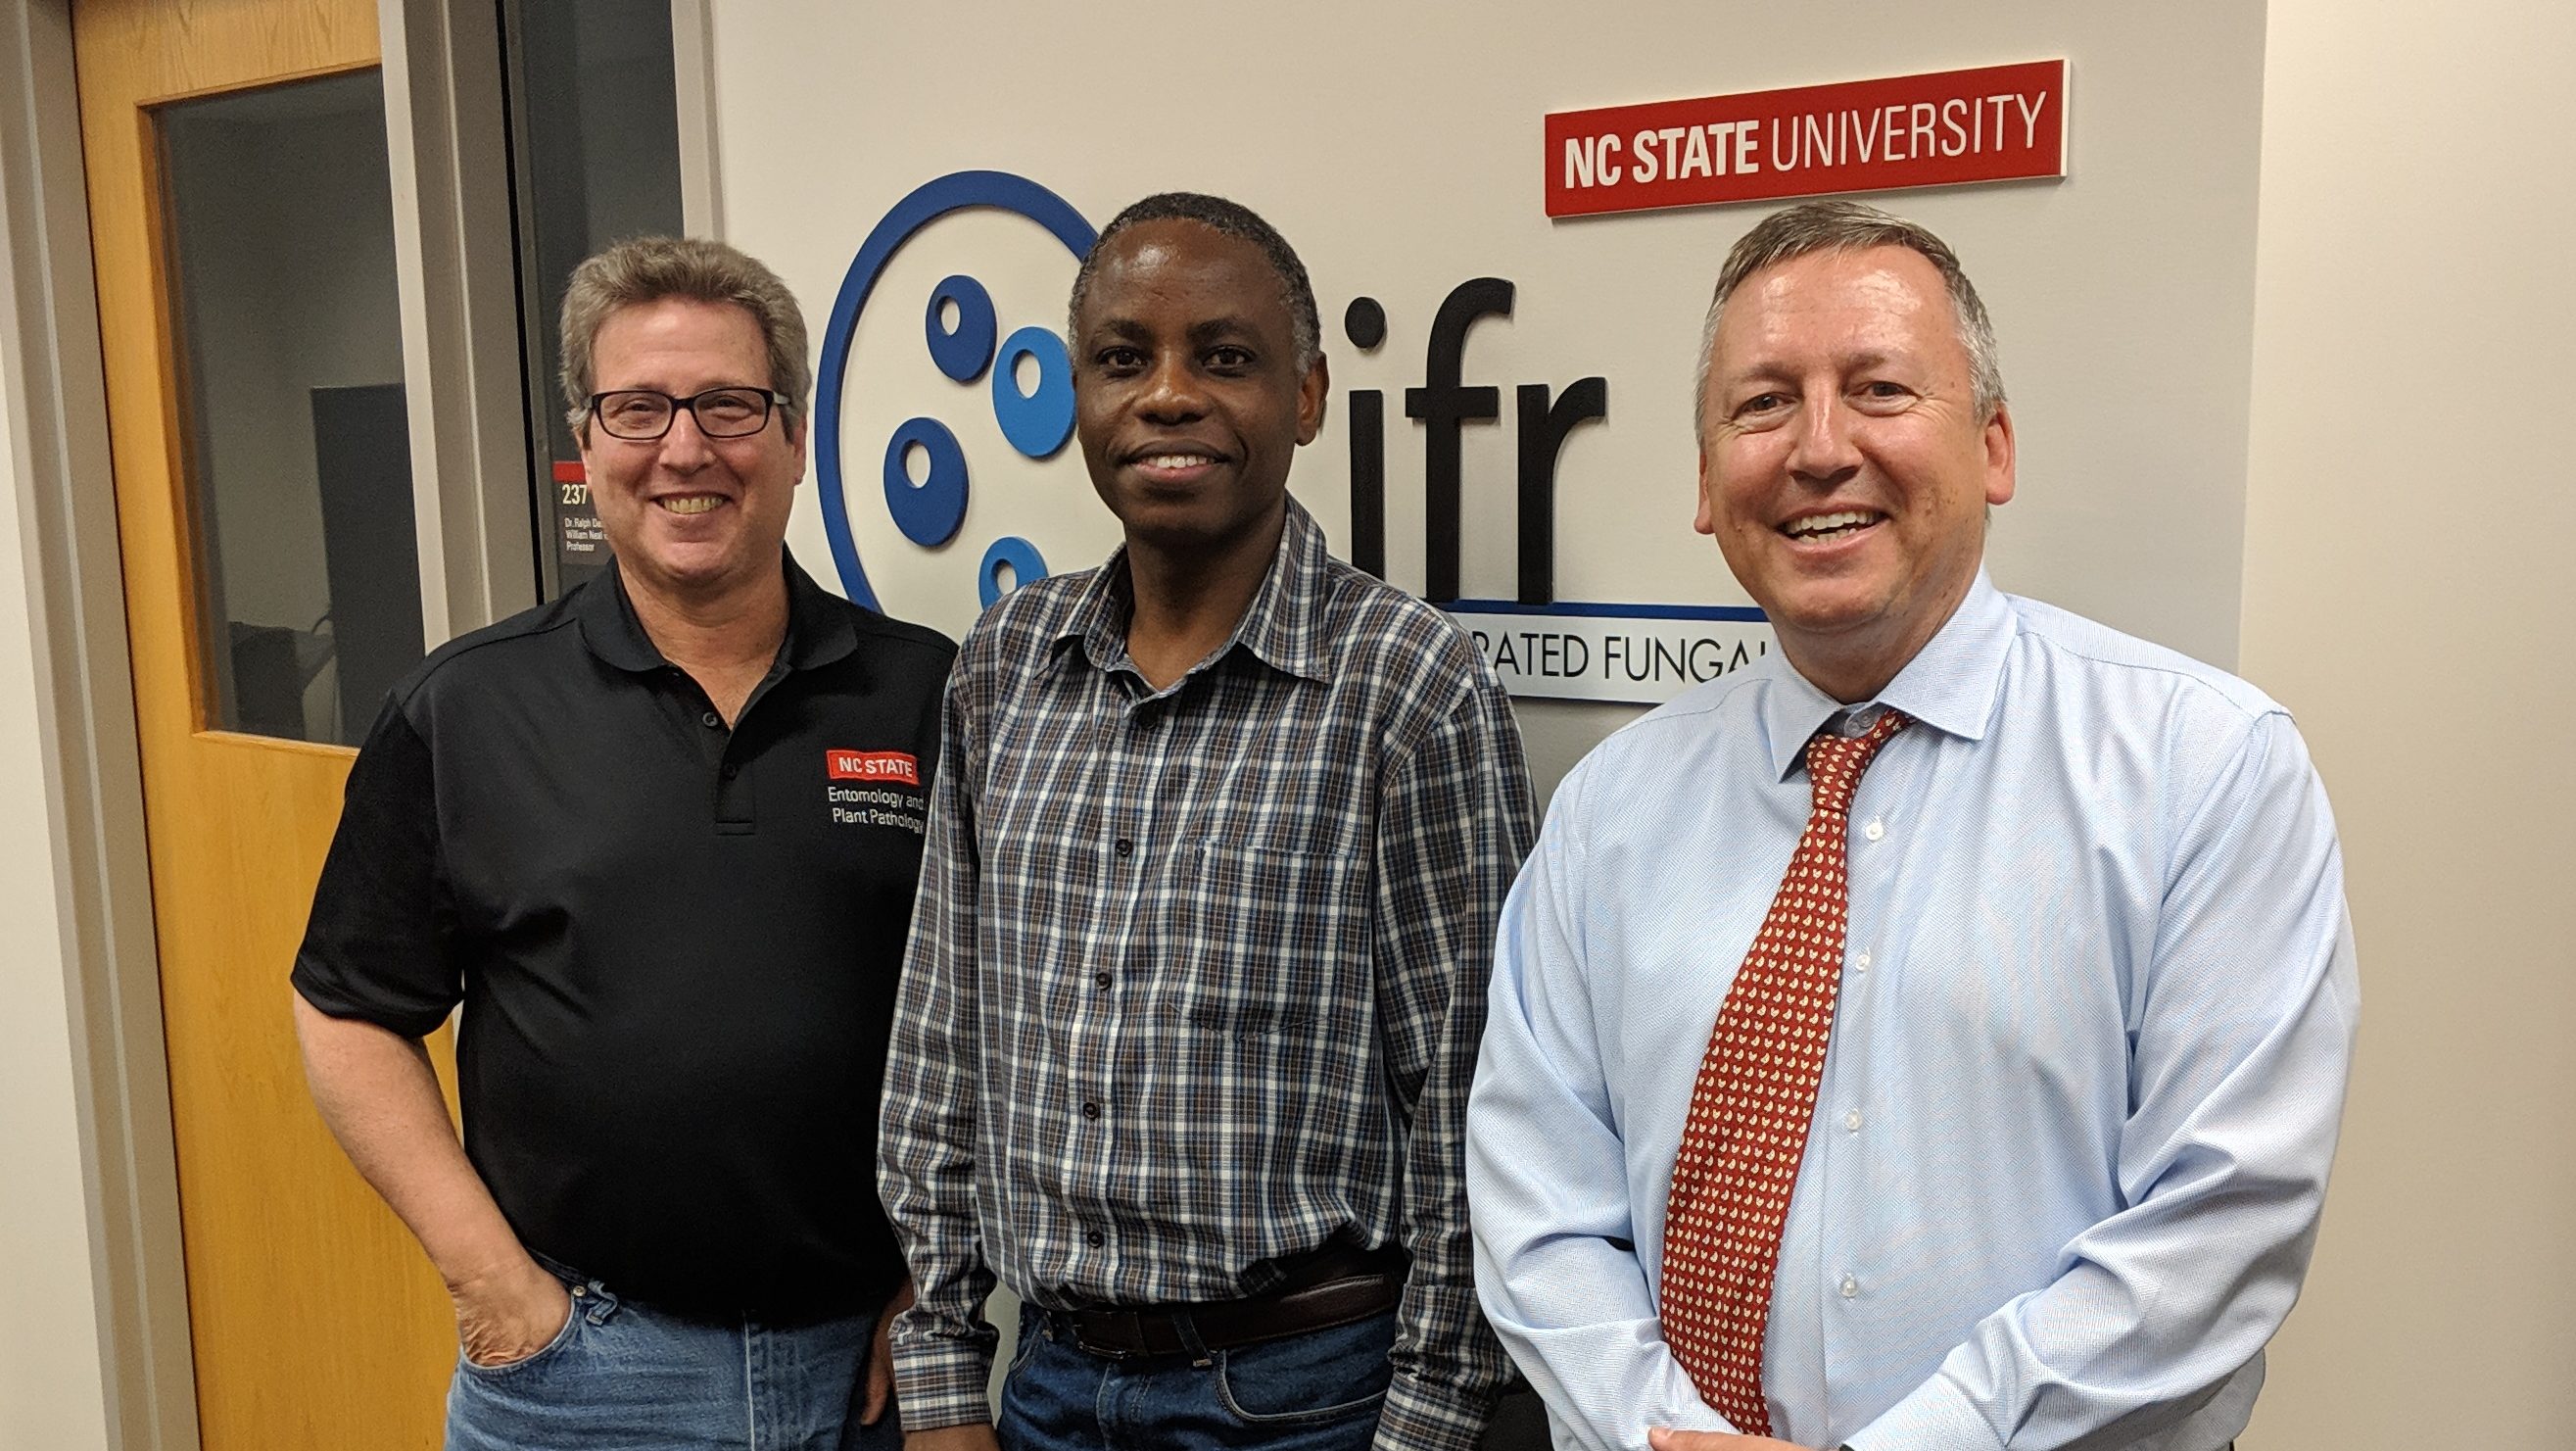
left=814, top=170, right=1770, bottom=705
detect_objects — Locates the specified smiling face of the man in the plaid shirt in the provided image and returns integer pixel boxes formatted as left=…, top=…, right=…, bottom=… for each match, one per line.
left=1074, top=219, right=1326, bottom=561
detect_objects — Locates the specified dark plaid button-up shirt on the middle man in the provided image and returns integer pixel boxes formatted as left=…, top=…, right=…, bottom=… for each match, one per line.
left=881, top=500, right=1533, bottom=1448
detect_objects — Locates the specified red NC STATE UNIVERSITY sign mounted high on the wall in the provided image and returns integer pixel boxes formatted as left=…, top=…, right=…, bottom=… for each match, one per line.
left=1546, top=60, right=2066, bottom=217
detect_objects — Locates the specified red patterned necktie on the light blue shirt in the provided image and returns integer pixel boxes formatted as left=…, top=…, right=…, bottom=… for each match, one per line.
left=1664, top=711, right=1909, bottom=1435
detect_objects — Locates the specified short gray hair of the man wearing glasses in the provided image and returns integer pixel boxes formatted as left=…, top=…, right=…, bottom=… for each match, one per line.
left=564, top=237, right=814, bottom=436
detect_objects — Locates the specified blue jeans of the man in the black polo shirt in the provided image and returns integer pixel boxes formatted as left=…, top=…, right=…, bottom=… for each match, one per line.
left=449, top=1281, right=904, bottom=1451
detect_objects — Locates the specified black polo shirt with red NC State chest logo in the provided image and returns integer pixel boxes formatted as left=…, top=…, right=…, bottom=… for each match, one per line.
left=294, top=559, right=956, bottom=1322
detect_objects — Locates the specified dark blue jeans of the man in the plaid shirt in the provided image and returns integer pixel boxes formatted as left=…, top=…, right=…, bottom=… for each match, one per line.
left=997, top=1304, right=1396, bottom=1451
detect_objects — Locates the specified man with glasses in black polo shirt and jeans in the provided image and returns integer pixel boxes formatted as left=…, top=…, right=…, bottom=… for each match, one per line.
left=294, top=240, right=956, bottom=1451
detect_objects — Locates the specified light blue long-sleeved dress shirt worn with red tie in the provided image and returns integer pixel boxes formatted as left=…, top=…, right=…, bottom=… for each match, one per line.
left=1465, top=575, right=2357, bottom=1451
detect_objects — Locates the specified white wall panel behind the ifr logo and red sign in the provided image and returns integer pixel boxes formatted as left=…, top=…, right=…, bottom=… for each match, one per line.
left=714, top=0, right=2262, bottom=792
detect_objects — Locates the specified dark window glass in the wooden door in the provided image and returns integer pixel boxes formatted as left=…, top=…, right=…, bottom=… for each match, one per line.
left=155, top=70, right=422, bottom=745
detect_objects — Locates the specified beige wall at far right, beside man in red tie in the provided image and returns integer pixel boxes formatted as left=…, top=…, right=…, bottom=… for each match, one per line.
left=2244, top=0, right=2576, bottom=1451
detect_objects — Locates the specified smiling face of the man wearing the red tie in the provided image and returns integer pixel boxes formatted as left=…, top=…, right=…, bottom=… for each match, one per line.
left=1697, top=248, right=2012, bottom=701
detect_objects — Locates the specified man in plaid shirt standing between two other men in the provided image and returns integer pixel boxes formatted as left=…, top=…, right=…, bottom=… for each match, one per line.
left=881, top=193, right=1533, bottom=1451
